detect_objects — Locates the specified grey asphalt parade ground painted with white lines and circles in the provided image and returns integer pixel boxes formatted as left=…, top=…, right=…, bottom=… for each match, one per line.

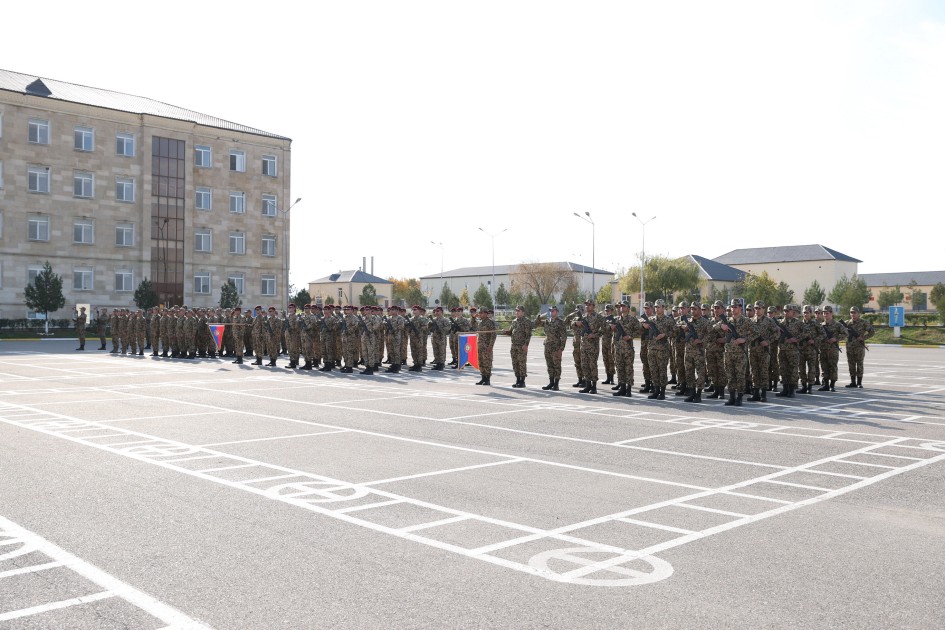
left=0, top=339, right=945, bottom=630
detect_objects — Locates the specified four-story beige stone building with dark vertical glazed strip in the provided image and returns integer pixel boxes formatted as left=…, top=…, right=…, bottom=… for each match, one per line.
left=0, top=70, right=291, bottom=318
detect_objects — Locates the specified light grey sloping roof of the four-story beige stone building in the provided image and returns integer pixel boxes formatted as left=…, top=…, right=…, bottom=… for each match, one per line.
left=0, top=70, right=289, bottom=140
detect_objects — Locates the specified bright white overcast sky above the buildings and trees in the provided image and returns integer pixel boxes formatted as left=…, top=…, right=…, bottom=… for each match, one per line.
left=0, top=0, right=945, bottom=286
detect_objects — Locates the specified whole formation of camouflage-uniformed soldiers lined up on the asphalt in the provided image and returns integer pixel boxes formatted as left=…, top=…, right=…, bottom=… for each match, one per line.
left=77, top=300, right=873, bottom=406
